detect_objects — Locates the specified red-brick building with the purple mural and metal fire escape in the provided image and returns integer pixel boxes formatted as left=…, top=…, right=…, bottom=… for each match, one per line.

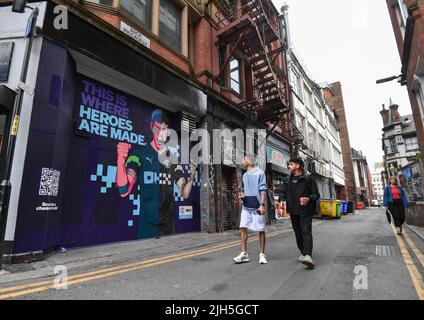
left=0, top=0, right=296, bottom=254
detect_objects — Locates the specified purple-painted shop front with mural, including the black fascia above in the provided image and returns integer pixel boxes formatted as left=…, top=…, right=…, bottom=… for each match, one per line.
left=2, top=2, right=207, bottom=254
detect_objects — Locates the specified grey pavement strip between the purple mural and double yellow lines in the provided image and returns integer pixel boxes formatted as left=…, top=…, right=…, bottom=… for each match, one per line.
left=0, top=219, right=292, bottom=284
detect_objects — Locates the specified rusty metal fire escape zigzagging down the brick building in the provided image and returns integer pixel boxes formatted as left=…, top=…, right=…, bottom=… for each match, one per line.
left=216, top=0, right=301, bottom=141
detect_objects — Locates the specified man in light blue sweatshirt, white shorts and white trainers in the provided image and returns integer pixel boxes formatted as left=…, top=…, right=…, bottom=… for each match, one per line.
left=233, top=155, right=268, bottom=264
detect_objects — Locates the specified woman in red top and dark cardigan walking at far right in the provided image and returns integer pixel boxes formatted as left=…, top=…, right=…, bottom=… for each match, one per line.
left=384, top=177, right=409, bottom=235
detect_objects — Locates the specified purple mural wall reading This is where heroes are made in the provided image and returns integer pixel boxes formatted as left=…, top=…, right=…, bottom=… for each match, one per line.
left=14, top=40, right=200, bottom=253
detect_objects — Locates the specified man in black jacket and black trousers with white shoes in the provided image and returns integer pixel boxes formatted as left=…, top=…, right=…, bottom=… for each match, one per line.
left=279, top=158, right=320, bottom=269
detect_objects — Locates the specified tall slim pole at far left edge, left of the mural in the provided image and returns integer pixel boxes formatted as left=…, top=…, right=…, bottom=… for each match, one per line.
left=0, top=0, right=39, bottom=270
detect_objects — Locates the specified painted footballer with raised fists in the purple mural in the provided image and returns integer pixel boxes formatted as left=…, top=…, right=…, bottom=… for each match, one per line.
left=116, top=109, right=197, bottom=239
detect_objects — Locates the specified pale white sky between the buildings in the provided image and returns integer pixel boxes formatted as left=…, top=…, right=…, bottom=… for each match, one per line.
left=273, top=0, right=412, bottom=171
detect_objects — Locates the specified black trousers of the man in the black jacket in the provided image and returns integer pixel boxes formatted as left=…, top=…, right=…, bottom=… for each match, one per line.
left=290, top=214, right=313, bottom=256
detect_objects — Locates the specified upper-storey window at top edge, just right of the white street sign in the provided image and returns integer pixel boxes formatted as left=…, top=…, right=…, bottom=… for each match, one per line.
left=159, top=0, right=181, bottom=51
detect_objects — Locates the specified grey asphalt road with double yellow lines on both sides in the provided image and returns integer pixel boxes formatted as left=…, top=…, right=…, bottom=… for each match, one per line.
left=0, top=209, right=424, bottom=300
